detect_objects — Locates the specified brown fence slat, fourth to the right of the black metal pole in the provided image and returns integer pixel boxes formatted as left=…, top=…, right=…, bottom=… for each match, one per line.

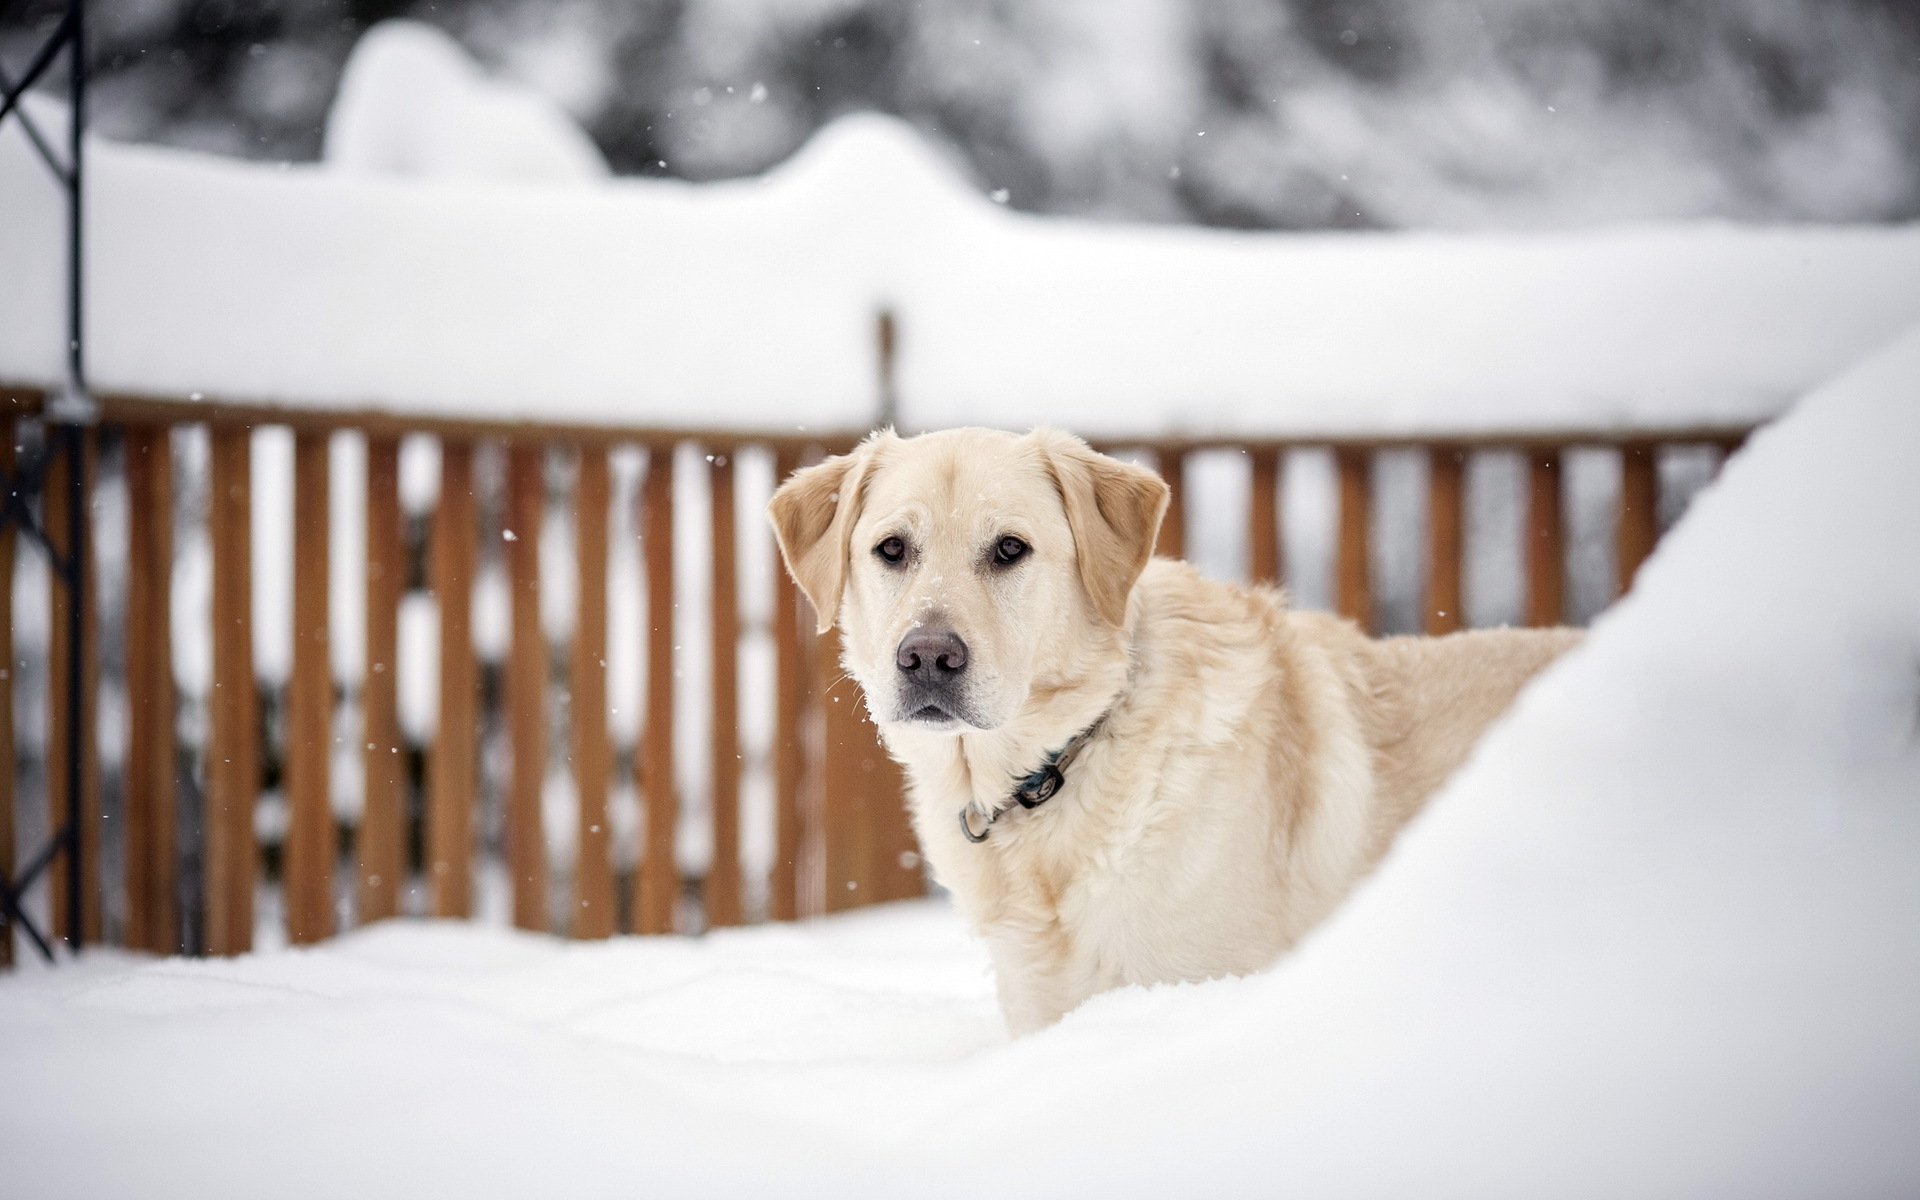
left=353, top=438, right=407, bottom=924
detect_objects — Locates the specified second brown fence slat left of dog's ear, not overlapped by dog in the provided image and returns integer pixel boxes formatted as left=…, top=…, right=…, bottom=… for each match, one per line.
left=634, top=442, right=680, bottom=933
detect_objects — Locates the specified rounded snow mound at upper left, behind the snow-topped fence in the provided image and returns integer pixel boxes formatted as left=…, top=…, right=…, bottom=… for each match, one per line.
left=323, top=21, right=609, bottom=182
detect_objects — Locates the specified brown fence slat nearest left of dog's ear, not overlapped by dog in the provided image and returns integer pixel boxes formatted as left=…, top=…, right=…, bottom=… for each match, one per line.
left=705, top=449, right=737, bottom=925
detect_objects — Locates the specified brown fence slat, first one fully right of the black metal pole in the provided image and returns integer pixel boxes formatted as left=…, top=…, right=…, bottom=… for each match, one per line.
left=121, top=424, right=186, bottom=954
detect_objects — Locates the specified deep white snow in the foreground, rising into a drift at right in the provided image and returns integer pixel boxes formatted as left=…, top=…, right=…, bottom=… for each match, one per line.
left=0, top=332, right=1920, bottom=1200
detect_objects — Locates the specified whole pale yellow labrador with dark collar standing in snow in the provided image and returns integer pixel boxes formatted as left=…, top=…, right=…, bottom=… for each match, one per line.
left=768, top=430, right=1576, bottom=1033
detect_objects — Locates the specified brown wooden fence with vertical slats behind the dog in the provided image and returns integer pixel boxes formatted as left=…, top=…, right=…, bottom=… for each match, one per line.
left=0, top=392, right=1747, bottom=967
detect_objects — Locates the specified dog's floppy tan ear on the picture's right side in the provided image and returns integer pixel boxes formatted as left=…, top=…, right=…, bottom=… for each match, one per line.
left=1035, top=430, right=1169, bottom=626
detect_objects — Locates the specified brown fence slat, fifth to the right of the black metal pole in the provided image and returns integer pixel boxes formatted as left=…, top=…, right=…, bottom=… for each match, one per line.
left=426, top=442, right=480, bottom=916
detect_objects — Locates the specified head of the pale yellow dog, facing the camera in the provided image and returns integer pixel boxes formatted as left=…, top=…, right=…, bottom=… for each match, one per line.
left=768, top=430, right=1167, bottom=732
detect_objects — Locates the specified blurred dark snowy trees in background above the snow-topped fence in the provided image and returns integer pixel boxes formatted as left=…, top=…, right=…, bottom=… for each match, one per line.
left=0, top=0, right=1920, bottom=228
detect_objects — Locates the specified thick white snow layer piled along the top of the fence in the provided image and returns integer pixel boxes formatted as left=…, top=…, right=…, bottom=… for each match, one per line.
left=0, top=56, right=1920, bottom=436
